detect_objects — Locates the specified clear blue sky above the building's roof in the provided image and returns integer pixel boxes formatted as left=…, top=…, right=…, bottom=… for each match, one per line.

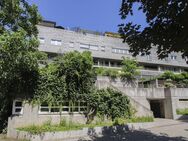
left=28, top=0, right=146, bottom=32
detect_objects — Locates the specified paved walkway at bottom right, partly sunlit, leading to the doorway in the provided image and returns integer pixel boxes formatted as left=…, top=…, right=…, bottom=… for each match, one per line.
left=66, top=119, right=188, bottom=141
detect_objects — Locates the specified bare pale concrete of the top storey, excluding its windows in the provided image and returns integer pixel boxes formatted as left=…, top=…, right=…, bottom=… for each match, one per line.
left=38, top=25, right=188, bottom=68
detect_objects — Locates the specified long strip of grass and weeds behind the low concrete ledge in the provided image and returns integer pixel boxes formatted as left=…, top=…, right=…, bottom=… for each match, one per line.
left=17, top=117, right=153, bottom=134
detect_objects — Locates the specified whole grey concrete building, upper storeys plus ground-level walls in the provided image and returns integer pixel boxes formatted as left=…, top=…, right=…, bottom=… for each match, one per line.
left=8, top=22, right=188, bottom=135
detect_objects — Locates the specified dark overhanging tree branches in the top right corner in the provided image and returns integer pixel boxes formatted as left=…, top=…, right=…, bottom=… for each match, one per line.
left=119, top=0, right=188, bottom=58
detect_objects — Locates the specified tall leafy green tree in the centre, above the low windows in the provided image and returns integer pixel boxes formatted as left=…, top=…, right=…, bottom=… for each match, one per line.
left=55, top=51, right=95, bottom=102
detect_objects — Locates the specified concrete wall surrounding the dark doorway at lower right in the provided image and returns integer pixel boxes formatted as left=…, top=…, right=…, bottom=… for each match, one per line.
left=96, top=76, right=188, bottom=119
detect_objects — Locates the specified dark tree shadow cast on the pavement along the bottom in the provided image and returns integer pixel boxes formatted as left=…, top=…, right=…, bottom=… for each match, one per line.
left=79, top=126, right=188, bottom=141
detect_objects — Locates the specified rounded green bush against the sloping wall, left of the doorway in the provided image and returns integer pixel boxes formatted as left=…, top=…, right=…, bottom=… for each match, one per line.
left=94, top=88, right=131, bottom=120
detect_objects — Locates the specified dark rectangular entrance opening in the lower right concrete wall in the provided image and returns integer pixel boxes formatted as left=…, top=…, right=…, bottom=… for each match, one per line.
left=150, top=100, right=164, bottom=118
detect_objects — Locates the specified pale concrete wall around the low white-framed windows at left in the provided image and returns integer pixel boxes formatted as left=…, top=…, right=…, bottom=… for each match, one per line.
left=8, top=103, right=86, bottom=130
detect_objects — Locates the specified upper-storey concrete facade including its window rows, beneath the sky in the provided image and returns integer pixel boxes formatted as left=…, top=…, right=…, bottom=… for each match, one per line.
left=38, top=21, right=188, bottom=76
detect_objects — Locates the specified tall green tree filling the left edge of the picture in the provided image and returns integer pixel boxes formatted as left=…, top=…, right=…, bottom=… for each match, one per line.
left=0, top=0, right=43, bottom=132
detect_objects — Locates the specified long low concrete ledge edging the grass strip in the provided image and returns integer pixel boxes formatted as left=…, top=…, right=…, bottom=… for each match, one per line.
left=7, top=122, right=158, bottom=141
